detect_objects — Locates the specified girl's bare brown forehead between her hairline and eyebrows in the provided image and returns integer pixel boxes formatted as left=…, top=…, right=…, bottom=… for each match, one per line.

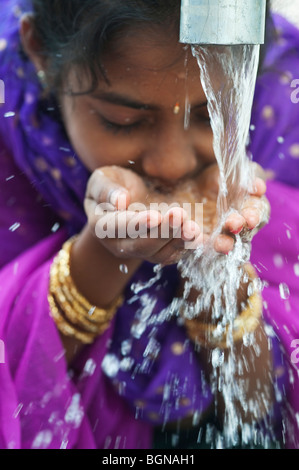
left=99, top=30, right=200, bottom=97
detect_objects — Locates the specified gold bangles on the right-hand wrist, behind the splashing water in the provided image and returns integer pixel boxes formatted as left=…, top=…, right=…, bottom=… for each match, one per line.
left=184, top=264, right=262, bottom=349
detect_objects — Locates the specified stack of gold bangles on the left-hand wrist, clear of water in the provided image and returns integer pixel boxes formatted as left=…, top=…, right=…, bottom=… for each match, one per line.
left=48, top=238, right=123, bottom=344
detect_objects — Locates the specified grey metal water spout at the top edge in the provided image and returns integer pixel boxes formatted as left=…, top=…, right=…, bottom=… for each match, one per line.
left=180, top=0, right=266, bottom=45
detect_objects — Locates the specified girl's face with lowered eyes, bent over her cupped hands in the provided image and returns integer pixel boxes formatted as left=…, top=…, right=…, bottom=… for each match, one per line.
left=61, top=27, right=215, bottom=184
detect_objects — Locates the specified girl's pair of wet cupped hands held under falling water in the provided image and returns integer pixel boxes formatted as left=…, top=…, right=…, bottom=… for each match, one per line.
left=84, top=164, right=269, bottom=264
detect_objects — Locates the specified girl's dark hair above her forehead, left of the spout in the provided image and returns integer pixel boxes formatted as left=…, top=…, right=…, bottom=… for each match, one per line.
left=33, top=0, right=181, bottom=90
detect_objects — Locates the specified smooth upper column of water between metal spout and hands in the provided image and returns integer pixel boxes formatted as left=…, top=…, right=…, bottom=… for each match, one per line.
left=192, top=45, right=260, bottom=215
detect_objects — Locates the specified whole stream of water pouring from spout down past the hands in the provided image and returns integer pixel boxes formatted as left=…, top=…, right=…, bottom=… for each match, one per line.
left=179, top=45, right=272, bottom=448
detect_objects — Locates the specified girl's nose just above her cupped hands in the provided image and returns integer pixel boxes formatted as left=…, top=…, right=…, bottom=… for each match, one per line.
left=142, top=128, right=198, bottom=183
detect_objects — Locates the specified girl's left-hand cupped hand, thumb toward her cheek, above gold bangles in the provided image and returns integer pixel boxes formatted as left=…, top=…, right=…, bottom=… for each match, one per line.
left=84, top=166, right=201, bottom=264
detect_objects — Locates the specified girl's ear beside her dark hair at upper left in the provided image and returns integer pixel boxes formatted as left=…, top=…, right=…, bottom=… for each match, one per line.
left=20, top=13, right=46, bottom=72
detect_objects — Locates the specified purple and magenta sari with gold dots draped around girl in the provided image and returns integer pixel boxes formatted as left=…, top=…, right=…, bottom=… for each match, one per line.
left=0, top=0, right=299, bottom=449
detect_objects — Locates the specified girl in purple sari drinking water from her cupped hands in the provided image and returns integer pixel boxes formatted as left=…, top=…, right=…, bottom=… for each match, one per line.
left=0, top=0, right=298, bottom=448
